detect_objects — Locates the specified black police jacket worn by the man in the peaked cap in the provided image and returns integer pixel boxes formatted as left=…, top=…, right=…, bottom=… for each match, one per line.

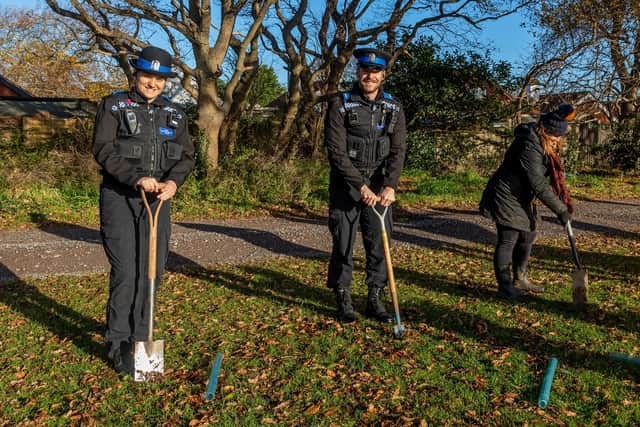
left=324, top=84, right=407, bottom=194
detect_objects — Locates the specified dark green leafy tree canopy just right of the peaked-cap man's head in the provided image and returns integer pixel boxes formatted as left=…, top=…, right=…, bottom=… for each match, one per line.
left=385, top=38, right=516, bottom=130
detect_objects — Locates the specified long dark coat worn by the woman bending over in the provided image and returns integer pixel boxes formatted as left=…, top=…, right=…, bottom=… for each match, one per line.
left=480, top=124, right=567, bottom=231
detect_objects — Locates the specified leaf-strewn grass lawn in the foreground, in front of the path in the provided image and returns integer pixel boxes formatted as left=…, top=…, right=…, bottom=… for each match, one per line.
left=0, top=233, right=640, bottom=426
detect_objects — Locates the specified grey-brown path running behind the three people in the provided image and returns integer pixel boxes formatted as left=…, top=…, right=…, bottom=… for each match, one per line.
left=0, top=200, right=640, bottom=282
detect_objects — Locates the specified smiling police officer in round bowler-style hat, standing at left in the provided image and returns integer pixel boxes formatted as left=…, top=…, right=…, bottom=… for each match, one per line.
left=93, top=47, right=194, bottom=373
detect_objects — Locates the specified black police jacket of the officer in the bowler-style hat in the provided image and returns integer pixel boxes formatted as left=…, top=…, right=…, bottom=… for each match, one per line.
left=93, top=90, right=195, bottom=187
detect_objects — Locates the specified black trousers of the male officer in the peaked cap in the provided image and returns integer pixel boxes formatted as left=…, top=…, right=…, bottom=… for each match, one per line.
left=327, top=177, right=393, bottom=289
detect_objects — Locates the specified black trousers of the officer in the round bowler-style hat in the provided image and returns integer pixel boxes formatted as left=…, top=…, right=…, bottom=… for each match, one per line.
left=100, top=183, right=171, bottom=353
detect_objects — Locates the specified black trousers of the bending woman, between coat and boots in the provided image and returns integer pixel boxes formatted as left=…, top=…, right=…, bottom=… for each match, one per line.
left=493, top=224, right=536, bottom=281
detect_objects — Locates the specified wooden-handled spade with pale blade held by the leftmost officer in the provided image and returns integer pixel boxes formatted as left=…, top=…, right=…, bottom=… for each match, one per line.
left=133, top=185, right=164, bottom=382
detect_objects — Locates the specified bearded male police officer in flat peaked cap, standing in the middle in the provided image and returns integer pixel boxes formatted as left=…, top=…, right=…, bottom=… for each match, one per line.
left=325, top=49, right=406, bottom=323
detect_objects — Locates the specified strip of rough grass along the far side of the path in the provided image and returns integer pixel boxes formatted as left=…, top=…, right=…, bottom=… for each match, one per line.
left=0, top=166, right=640, bottom=229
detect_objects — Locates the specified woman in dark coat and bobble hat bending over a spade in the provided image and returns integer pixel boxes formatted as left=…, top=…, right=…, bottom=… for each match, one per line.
left=480, top=104, right=575, bottom=299
